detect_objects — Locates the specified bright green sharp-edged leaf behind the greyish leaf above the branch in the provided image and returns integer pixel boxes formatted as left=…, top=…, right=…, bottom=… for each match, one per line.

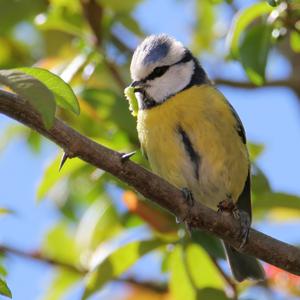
left=18, top=68, right=80, bottom=115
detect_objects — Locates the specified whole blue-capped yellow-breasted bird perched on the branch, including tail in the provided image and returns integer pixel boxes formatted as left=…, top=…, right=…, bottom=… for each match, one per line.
left=130, top=34, right=265, bottom=282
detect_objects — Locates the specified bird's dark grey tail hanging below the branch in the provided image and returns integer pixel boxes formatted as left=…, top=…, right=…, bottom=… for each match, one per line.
left=224, top=243, right=265, bottom=281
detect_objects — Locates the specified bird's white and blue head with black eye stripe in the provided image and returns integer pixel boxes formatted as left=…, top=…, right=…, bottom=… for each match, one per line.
left=130, top=34, right=206, bottom=109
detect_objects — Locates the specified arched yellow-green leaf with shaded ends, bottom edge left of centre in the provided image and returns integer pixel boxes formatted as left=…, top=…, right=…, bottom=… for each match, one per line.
left=84, top=240, right=163, bottom=299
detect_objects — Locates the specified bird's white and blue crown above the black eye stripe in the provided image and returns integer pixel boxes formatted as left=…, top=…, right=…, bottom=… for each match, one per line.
left=130, top=34, right=185, bottom=80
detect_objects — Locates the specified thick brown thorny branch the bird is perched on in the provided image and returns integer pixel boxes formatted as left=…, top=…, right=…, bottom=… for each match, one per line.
left=0, top=91, right=300, bottom=275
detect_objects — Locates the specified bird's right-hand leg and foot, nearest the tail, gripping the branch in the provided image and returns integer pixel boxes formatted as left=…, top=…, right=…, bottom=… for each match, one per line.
left=218, top=197, right=251, bottom=249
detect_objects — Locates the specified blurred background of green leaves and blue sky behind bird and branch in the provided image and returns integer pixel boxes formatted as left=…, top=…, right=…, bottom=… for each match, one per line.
left=0, top=0, right=300, bottom=299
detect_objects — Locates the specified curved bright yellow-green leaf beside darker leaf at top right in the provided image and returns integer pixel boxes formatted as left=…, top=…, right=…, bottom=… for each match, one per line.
left=227, top=2, right=273, bottom=58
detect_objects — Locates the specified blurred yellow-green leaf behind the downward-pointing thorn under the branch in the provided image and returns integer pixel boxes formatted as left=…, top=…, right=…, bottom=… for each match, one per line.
left=37, top=155, right=84, bottom=201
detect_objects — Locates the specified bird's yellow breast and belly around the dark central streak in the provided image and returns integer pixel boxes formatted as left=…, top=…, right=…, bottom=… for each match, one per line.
left=137, top=85, right=249, bottom=208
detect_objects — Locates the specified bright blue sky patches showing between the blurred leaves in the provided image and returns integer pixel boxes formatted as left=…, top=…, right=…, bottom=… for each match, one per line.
left=0, top=0, right=300, bottom=300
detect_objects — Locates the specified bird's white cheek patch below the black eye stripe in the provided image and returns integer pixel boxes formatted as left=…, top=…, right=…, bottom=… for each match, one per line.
left=146, top=61, right=195, bottom=103
